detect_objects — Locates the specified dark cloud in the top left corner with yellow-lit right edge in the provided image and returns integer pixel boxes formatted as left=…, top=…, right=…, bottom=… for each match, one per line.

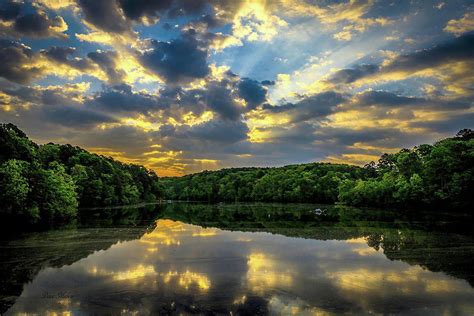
left=0, top=1, right=67, bottom=38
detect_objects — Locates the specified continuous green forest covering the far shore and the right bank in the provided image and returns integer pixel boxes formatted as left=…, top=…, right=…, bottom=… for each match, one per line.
left=162, top=129, right=474, bottom=210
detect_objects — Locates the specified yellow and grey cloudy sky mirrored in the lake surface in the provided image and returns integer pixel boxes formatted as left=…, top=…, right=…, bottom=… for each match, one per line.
left=9, top=220, right=474, bottom=314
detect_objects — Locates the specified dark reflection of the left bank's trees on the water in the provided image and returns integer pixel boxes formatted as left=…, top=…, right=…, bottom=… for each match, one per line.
left=0, top=208, right=156, bottom=314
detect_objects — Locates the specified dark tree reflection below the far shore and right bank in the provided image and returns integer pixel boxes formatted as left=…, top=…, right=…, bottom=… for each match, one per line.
left=160, top=204, right=474, bottom=286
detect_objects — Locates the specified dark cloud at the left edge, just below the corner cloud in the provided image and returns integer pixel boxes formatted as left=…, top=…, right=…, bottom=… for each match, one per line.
left=0, top=39, right=43, bottom=83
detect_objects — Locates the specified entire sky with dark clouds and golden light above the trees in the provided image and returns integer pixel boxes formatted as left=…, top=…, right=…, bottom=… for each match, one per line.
left=0, top=0, right=474, bottom=176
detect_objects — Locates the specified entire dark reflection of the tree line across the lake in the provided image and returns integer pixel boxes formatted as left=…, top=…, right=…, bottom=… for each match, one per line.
left=0, top=203, right=474, bottom=313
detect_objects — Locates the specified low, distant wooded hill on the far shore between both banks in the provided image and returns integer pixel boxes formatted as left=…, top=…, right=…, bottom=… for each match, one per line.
left=163, top=163, right=370, bottom=203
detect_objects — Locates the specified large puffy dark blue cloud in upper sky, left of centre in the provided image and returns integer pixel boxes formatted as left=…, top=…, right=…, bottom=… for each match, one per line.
left=139, top=30, right=209, bottom=83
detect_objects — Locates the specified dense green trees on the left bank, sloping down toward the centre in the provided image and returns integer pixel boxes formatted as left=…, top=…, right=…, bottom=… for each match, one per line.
left=0, top=124, right=163, bottom=226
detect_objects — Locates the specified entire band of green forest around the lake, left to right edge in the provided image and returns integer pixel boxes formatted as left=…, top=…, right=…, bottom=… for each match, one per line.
left=0, top=124, right=474, bottom=225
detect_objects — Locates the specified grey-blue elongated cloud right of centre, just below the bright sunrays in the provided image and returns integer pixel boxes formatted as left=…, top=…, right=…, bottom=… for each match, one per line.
left=263, top=91, right=346, bottom=122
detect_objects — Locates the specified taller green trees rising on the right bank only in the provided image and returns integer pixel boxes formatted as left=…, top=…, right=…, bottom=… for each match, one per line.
left=339, top=129, right=474, bottom=211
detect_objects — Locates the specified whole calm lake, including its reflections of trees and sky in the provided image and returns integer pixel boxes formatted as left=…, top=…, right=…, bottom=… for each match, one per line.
left=0, top=203, right=474, bottom=315
